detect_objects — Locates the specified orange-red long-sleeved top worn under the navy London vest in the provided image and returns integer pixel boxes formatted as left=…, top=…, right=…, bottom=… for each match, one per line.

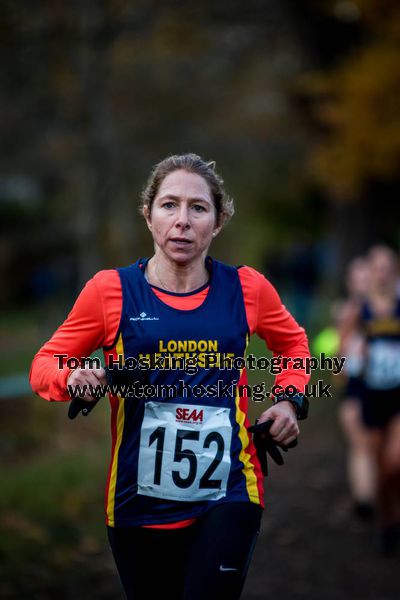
left=30, top=266, right=309, bottom=528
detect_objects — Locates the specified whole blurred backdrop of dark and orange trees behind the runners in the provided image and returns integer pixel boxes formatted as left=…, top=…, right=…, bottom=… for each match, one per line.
left=0, top=0, right=400, bottom=302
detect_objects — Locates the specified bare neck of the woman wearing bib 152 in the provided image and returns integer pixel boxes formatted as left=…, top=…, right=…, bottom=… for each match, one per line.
left=146, top=253, right=209, bottom=294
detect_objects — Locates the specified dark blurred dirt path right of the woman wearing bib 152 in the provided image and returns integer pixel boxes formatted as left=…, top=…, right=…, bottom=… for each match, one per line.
left=243, top=400, right=400, bottom=600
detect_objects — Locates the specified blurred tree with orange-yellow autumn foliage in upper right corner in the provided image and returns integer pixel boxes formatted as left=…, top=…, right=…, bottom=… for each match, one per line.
left=299, top=0, right=400, bottom=268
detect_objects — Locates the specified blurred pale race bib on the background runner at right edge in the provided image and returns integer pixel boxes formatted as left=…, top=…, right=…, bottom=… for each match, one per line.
left=365, top=340, right=400, bottom=390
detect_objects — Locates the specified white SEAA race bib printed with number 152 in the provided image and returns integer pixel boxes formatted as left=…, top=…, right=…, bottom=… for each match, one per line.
left=138, top=402, right=232, bottom=502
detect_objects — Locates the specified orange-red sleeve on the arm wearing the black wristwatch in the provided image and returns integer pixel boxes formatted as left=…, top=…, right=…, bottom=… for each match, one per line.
left=239, top=267, right=310, bottom=391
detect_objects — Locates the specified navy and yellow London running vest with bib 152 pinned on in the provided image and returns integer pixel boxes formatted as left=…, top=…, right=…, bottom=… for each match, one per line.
left=106, top=257, right=263, bottom=526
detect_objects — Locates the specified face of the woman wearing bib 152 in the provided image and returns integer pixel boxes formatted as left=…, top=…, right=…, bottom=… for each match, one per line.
left=144, top=169, right=221, bottom=264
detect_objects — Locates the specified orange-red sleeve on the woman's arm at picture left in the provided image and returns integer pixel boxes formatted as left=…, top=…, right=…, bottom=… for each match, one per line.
left=29, top=270, right=122, bottom=401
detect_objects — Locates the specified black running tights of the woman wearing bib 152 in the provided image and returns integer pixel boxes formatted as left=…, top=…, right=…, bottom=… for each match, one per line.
left=107, top=502, right=262, bottom=600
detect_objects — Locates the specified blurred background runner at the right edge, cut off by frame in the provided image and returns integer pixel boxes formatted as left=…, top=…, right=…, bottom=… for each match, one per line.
left=360, top=246, right=400, bottom=554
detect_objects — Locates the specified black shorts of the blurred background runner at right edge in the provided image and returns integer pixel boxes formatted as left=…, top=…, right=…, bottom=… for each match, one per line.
left=362, top=388, right=400, bottom=428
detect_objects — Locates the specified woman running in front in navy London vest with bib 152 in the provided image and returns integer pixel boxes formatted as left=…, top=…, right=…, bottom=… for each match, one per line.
left=30, top=154, right=309, bottom=600
